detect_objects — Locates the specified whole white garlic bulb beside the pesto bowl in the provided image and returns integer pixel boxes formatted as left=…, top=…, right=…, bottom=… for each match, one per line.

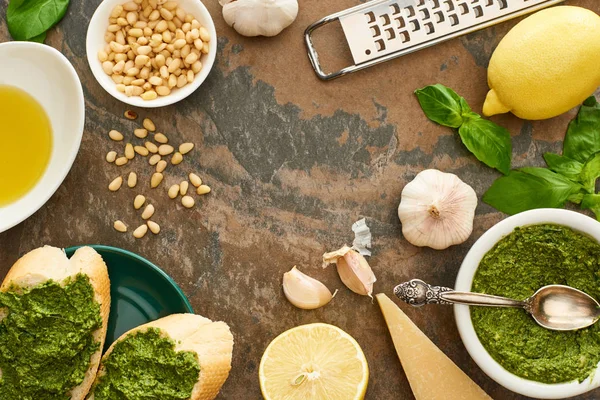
left=398, top=169, right=477, bottom=250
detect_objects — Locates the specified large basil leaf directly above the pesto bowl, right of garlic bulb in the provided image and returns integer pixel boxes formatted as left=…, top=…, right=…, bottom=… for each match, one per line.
left=483, top=168, right=581, bottom=215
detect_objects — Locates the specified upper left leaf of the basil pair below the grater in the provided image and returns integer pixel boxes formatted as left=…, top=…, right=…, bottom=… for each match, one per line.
left=415, top=83, right=471, bottom=128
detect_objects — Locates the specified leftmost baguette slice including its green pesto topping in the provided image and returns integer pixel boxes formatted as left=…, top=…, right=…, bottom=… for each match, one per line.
left=0, top=246, right=110, bottom=400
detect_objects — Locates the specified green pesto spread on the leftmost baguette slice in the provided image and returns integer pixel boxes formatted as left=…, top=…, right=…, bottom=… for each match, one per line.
left=0, top=275, right=102, bottom=400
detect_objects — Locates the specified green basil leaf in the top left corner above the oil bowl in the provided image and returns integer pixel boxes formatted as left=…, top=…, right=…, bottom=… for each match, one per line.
left=6, top=0, right=69, bottom=40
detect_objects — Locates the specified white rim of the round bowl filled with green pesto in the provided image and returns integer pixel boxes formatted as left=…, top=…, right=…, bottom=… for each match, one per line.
left=454, top=209, right=600, bottom=399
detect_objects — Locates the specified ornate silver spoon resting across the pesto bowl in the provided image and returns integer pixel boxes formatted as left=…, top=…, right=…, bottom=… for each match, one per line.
left=394, top=279, right=600, bottom=331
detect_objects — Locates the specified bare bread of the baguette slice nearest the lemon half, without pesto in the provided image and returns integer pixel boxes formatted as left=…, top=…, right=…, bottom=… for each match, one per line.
left=88, top=314, right=233, bottom=400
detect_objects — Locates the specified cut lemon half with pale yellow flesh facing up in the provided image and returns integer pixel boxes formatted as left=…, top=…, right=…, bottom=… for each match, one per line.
left=259, top=324, right=369, bottom=400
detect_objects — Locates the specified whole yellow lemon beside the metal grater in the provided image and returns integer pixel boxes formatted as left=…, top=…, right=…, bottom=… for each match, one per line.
left=483, top=6, right=600, bottom=120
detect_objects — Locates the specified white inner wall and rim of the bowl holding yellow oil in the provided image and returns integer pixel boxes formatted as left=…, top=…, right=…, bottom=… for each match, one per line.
left=0, top=42, right=85, bottom=232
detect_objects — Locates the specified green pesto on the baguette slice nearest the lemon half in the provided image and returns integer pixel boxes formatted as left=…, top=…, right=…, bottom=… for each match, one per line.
left=94, top=328, right=200, bottom=400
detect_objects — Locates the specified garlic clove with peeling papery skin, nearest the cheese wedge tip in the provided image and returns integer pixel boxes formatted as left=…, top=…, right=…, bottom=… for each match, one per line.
left=323, top=246, right=377, bottom=297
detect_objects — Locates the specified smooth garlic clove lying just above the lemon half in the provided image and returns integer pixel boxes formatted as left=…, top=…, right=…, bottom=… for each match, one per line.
left=283, top=267, right=335, bottom=310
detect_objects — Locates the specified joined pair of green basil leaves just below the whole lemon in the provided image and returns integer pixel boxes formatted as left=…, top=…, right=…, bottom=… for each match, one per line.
left=415, top=83, right=512, bottom=175
